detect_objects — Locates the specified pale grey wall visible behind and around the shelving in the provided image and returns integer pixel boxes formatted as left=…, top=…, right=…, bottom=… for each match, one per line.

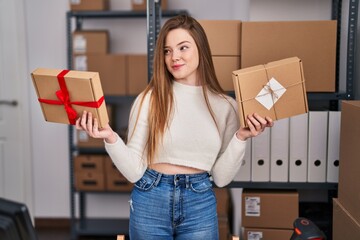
left=25, top=0, right=331, bottom=234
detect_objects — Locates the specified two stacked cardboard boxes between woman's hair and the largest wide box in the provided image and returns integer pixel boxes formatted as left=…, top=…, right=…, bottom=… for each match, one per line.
left=199, top=20, right=241, bottom=91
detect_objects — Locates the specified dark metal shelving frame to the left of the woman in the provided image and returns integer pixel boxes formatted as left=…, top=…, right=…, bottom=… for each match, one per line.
left=66, top=0, right=188, bottom=240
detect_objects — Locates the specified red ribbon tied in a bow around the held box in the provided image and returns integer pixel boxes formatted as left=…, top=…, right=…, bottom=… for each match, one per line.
left=39, top=70, right=104, bottom=125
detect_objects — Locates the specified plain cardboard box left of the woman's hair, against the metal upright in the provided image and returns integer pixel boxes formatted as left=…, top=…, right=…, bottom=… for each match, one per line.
left=127, top=54, right=148, bottom=95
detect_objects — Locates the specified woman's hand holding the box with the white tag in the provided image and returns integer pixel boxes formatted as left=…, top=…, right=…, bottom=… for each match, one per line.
left=236, top=113, right=274, bottom=141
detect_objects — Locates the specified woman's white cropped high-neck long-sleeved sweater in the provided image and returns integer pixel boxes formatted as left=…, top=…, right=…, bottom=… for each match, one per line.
left=105, top=81, right=246, bottom=187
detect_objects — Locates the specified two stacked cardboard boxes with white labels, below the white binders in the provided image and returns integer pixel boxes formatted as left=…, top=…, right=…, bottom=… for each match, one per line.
left=241, top=190, right=299, bottom=240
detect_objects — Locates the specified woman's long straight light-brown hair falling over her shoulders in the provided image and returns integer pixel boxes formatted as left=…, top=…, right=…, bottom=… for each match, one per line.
left=134, top=15, right=225, bottom=164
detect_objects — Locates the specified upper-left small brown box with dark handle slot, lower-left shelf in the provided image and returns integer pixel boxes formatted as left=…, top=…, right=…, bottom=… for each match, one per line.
left=74, top=155, right=104, bottom=173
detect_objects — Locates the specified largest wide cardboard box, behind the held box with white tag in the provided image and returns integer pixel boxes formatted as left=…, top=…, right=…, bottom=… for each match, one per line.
left=241, top=21, right=337, bottom=92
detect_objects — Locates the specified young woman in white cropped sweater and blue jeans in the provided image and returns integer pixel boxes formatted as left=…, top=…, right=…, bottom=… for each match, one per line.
left=76, top=16, right=273, bottom=240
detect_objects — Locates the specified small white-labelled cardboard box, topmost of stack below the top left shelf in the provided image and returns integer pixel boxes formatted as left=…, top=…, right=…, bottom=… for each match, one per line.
left=72, top=30, right=109, bottom=54
